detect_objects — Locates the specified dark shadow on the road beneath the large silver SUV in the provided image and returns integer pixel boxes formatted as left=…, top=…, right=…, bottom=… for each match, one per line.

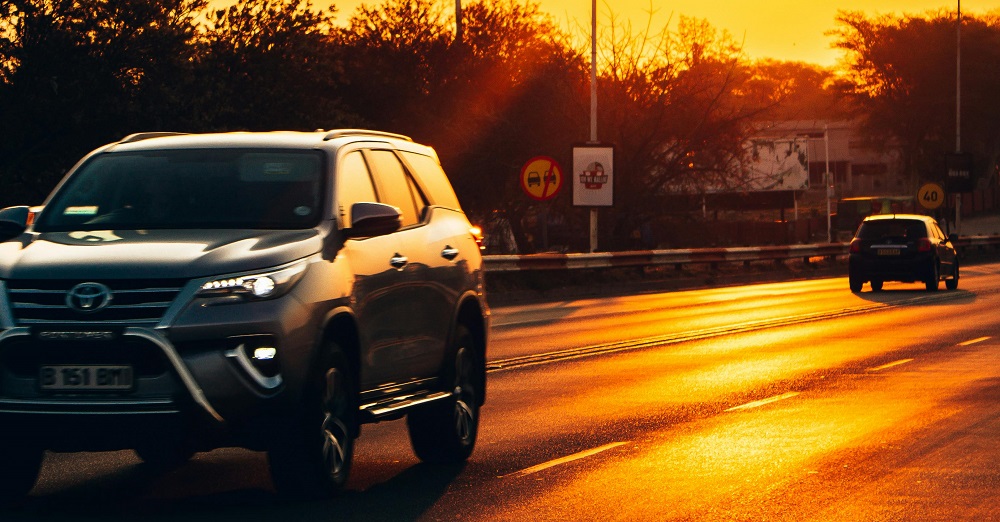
left=0, top=450, right=465, bottom=522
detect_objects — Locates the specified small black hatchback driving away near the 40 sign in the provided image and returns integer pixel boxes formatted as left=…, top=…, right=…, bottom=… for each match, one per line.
left=849, top=214, right=959, bottom=292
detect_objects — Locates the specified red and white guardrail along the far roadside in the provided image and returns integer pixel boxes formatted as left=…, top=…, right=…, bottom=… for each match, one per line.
left=483, top=235, right=1000, bottom=273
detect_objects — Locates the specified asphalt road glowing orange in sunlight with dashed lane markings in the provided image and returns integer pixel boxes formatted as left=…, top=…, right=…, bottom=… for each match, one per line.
left=9, top=264, right=1000, bottom=521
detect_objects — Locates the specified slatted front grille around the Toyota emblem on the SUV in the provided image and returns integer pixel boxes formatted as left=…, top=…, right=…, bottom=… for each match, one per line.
left=7, top=279, right=186, bottom=326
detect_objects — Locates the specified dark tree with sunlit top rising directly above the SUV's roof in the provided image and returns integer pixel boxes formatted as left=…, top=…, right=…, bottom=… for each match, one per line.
left=193, top=0, right=359, bottom=130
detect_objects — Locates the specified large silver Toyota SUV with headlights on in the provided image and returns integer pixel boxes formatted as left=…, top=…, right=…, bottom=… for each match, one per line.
left=0, top=129, right=489, bottom=498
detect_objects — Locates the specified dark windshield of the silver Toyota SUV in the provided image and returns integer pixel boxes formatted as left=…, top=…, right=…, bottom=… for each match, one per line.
left=35, top=149, right=323, bottom=232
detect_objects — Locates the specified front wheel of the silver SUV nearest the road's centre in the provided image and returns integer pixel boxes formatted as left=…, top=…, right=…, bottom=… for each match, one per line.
left=267, top=343, right=358, bottom=499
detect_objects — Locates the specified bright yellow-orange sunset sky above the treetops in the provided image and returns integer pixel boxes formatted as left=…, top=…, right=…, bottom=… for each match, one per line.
left=322, top=0, right=1000, bottom=65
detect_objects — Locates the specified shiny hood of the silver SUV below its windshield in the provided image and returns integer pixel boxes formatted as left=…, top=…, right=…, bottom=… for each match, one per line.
left=0, top=225, right=323, bottom=279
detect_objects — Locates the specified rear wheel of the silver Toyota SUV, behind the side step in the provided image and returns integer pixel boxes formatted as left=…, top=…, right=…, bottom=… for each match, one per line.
left=406, top=326, right=485, bottom=464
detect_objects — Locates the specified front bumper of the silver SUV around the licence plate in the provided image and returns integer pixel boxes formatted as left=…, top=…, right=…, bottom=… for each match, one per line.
left=0, top=292, right=315, bottom=451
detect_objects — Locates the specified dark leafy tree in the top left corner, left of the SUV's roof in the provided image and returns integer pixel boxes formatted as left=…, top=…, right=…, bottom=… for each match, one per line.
left=0, top=0, right=204, bottom=204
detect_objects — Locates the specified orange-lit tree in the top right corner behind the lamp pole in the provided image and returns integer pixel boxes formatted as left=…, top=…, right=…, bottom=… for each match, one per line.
left=833, top=12, right=1000, bottom=190
